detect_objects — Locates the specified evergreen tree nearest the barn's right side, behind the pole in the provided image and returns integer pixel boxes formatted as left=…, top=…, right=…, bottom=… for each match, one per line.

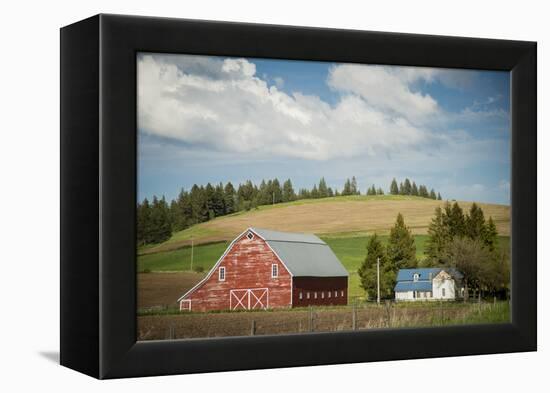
left=357, top=234, right=394, bottom=299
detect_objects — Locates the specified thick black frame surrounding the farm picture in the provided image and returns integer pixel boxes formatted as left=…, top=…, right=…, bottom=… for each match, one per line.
left=61, top=15, right=537, bottom=379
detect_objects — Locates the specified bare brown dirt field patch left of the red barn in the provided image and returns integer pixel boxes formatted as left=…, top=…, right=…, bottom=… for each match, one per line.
left=137, top=272, right=206, bottom=309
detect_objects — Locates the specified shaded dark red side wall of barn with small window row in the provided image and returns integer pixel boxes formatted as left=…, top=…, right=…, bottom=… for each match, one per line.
left=292, top=277, right=348, bottom=307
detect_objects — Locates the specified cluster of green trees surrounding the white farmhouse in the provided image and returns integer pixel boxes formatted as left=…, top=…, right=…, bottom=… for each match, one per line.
left=358, top=202, right=510, bottom=301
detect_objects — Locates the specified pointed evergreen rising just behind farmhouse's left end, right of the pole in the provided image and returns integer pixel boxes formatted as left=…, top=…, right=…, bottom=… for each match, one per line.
left=386, top=213, right=417, bottom=273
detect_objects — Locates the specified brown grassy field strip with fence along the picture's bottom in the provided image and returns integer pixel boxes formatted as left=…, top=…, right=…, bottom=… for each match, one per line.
left=137, top=303, right=509, bottom=340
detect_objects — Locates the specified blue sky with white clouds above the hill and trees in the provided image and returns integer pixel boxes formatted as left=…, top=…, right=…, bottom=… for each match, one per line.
left=138, top=53, right=510, bottom=204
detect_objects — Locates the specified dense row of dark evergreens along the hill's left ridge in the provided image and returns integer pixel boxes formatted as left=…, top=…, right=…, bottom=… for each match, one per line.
left=137, top=176, right=384, bottom=245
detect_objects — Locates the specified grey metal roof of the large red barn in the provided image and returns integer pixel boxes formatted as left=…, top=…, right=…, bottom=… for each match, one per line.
left=250, top=228, right=348, bottom=277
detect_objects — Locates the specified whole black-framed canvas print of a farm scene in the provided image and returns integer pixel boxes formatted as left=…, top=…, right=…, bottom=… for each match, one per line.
left=61, top=15, right=536, bottom=378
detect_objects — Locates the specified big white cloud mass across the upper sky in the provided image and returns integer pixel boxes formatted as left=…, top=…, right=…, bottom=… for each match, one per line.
left=138, top=55, right=438, bottom=160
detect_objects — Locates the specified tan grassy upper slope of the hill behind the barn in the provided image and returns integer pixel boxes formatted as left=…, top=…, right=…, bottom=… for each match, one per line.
left=139, top=195, right=510, bottom=254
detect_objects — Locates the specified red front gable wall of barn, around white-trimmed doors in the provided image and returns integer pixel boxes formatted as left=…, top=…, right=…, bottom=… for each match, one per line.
left=185, top=234, right=292, bottom=311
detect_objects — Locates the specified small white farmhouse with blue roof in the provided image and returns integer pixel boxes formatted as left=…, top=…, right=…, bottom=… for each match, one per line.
left=394, top=268, right=464, bottom=301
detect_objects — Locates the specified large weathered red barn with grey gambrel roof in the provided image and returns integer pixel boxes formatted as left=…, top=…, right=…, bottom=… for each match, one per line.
left=178, top=228, right=348, bottom=311
